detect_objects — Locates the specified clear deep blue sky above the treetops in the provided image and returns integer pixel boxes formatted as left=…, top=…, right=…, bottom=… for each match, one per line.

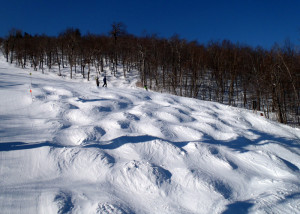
left=0, top=0, right=300, bottom=48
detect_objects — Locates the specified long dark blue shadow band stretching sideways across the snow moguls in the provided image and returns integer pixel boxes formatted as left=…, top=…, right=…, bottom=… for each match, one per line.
left=0, top=127, right=300, bottom=162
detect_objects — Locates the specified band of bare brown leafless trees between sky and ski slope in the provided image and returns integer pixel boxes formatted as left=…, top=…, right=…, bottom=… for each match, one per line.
left=0, top=23, right=300, bottom=125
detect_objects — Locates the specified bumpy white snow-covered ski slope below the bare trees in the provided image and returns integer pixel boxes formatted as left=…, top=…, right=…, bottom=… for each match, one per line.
left=0, top=59, right=300, bottom=213
